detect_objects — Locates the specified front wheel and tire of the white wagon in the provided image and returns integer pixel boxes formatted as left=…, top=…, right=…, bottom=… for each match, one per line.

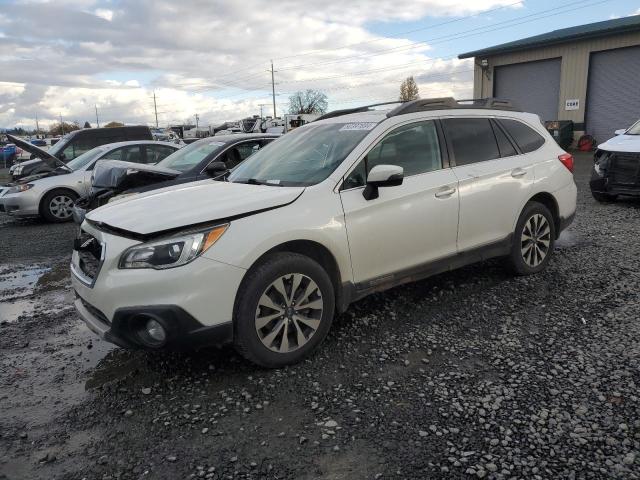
left=234, top=253, right=335, bottom=368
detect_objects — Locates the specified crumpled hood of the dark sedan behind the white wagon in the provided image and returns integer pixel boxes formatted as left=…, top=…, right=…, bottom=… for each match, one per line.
left=91, top=160, right=181, bottom=190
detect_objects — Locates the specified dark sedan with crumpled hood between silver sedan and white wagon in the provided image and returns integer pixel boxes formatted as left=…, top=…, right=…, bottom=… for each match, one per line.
left=73, top=133, right=279, bottom=224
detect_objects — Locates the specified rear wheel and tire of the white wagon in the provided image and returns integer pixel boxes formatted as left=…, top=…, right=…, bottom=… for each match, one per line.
left=507, top=202, right=556, bottom=275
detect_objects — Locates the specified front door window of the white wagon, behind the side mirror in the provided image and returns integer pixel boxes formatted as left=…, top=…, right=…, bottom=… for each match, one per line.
left=342, top=120, right=442, bottom=190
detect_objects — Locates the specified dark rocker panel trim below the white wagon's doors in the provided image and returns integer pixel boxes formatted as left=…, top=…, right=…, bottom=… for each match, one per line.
left=350, top=234, right=512, bottom=302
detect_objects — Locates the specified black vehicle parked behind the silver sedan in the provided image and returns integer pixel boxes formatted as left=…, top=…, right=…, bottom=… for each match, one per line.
left=7, top=126, right=153, bottom=180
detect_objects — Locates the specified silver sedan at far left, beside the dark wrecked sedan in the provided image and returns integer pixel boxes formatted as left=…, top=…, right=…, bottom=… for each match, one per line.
left=0, top=140, right=180, bottom=222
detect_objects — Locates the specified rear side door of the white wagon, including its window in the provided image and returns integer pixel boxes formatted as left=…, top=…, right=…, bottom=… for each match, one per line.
left=442, top=117, right=534, bottom=252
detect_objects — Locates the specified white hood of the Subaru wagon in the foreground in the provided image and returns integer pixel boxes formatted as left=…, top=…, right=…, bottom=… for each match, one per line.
left=86, top=180, right=304, bottom=236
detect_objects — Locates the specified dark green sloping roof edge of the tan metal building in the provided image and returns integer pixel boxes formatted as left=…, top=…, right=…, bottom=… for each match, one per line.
left=458, top=15, right=640, bottom=58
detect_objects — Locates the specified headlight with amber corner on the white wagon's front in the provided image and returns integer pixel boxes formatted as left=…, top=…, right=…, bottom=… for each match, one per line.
left=119, top=224, right=229, bottom=270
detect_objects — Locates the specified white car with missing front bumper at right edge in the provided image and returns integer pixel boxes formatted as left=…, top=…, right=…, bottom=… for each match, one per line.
left=589, top=120, right=640, bottom=202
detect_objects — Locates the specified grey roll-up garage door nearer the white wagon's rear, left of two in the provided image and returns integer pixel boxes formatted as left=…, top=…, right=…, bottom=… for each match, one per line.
left=493, top=58, right=561, bottom=121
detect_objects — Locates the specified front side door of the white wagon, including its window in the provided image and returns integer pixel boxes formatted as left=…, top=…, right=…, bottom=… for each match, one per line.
left=340, top=120, right=458, bottom=288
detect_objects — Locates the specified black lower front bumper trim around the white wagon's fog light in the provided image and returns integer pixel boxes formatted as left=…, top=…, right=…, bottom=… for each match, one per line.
left=74, top=296, right=233, bottom=350
